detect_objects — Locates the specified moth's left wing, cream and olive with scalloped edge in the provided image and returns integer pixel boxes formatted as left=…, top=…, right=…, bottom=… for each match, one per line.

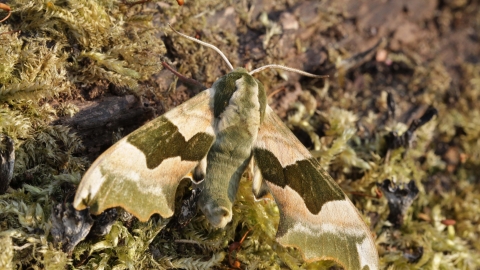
left=74, top=89, right=215, bottom=221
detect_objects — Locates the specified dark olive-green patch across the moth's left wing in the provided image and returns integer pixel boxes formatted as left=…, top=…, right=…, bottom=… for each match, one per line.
left=127, top=116, right=214, bottom=169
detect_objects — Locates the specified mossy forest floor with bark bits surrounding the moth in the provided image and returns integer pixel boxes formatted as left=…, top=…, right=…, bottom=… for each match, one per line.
left=0, top=0, right=480, bottom=269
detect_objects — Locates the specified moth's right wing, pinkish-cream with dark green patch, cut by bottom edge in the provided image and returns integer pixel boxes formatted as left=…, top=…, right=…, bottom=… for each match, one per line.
left=254, top=106, right=378, bottom=269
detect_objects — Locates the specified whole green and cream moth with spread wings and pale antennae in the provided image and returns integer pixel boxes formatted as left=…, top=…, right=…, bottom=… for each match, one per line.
left=74, top=25, right=379, bottom=269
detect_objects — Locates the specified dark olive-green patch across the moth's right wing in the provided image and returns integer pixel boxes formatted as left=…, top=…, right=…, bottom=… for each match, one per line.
left=254, top=148, right=345, bottom=215
